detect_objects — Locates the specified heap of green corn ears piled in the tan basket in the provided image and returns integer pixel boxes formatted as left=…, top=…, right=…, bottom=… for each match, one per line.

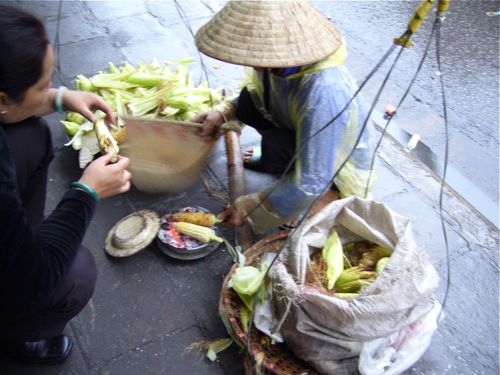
left=61, top=60, right=222, bottom=168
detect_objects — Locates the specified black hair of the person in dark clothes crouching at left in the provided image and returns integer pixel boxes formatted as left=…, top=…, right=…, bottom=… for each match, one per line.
left=0, top=5, right=49, bottom=102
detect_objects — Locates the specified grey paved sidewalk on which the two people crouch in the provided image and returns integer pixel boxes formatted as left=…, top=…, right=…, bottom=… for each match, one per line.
left=0, top=0, right=499, bottom=375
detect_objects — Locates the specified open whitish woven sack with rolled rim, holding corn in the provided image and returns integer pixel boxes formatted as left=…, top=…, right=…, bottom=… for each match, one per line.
left=271, top=197, right=439, bottom=374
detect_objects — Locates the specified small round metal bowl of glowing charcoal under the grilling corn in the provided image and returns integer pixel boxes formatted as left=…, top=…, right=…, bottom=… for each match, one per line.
left=155, top=206, right=220, bottom=260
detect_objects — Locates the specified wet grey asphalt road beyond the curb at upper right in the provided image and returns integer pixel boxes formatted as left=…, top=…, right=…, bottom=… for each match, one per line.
left=312, top=0, right=500, bottom=227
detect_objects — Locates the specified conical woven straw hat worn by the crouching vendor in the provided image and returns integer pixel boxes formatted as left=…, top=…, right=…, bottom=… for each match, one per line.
left=196, top=0, right=341, bottom=68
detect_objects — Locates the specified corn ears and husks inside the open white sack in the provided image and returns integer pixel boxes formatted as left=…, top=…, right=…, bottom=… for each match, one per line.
left=306, top=228, right=392, bottom=298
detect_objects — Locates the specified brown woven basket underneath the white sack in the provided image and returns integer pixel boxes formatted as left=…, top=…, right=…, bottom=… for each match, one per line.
left=219, top=231, right=317, bottom=375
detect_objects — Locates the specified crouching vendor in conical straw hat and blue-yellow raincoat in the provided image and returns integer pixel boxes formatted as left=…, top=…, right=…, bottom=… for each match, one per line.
left=194, top=0, right=373, bottom=232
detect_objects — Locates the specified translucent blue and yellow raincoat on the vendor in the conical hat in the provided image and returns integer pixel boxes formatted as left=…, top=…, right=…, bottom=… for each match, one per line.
left=230, top=44, right=374, bottom=233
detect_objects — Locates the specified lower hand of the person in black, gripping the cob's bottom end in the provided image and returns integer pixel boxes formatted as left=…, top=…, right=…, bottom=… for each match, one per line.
left=79, top=154, right=132, bottom=198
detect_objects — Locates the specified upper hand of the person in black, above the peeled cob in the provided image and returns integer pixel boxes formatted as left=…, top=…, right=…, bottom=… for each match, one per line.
left=63, top=90, right=115, bottom=124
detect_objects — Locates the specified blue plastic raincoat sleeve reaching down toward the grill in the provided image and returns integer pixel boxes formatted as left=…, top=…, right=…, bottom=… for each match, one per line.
left=268, top=70, right=357, bottom=218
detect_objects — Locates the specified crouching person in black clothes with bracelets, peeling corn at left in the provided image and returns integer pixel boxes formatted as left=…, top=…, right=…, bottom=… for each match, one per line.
left=0, top=5, right=131, bottom=363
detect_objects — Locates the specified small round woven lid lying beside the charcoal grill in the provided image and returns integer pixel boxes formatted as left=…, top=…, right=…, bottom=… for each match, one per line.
left=104, top=210, right=160, bottom=257
